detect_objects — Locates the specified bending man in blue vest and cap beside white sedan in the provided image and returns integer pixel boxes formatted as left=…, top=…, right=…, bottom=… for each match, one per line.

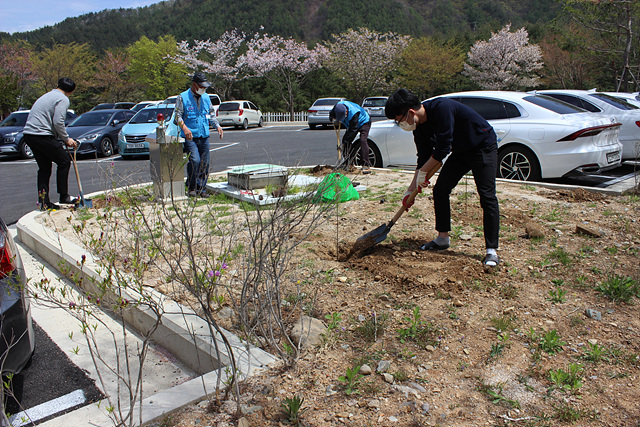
left=329, top=101, right=371, bottom=174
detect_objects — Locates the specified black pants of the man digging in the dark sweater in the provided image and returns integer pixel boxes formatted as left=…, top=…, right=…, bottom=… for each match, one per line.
left=433, top=144, right=500, bottom=249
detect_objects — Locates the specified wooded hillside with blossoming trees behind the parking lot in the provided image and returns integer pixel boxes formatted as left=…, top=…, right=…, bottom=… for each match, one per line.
left=0, top=0, right=640, bottom=115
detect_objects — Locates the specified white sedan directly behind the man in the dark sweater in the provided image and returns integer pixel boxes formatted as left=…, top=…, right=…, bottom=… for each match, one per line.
left=362, top=91, right=622, bottom=181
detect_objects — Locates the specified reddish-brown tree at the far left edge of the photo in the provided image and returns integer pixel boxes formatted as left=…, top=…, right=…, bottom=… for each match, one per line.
left=0, top=43, right=35, bottom=116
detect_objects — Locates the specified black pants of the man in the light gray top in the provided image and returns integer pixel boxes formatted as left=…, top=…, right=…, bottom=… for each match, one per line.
left=24, top=134, right=71, bottom=203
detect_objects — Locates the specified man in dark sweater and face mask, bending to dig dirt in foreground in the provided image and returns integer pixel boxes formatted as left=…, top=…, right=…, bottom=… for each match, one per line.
left=385, top=89, right=500, bottom=270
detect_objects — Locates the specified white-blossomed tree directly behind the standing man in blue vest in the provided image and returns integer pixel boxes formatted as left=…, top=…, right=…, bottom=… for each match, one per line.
left=173, top=29, right=246, bottom=98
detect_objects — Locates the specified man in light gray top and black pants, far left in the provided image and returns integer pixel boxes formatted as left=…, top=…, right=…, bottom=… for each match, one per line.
left=23, top=77, right=78, bottom=210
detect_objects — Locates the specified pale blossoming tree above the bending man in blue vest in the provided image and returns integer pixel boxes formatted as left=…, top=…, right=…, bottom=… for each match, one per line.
left=325, top=28, right=411, bottom=100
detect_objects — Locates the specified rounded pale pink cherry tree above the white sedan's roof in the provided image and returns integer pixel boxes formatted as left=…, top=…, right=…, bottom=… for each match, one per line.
left=464, top=24, right=543, bottom=90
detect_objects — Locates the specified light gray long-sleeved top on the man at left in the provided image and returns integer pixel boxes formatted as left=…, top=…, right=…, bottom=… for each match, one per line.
left=23, top=89, right=69, bottom=142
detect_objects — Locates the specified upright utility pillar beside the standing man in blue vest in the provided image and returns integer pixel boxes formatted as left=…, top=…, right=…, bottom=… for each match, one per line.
left=145, top=127, right=185, bottom=200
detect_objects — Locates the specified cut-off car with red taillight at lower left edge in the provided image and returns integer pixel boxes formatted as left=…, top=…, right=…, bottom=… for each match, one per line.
left=0, top=214, right=36, bottom=375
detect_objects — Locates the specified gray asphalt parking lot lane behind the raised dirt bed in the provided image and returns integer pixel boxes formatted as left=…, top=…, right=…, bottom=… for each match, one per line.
left=0, top=125, right=337, bottom=224
